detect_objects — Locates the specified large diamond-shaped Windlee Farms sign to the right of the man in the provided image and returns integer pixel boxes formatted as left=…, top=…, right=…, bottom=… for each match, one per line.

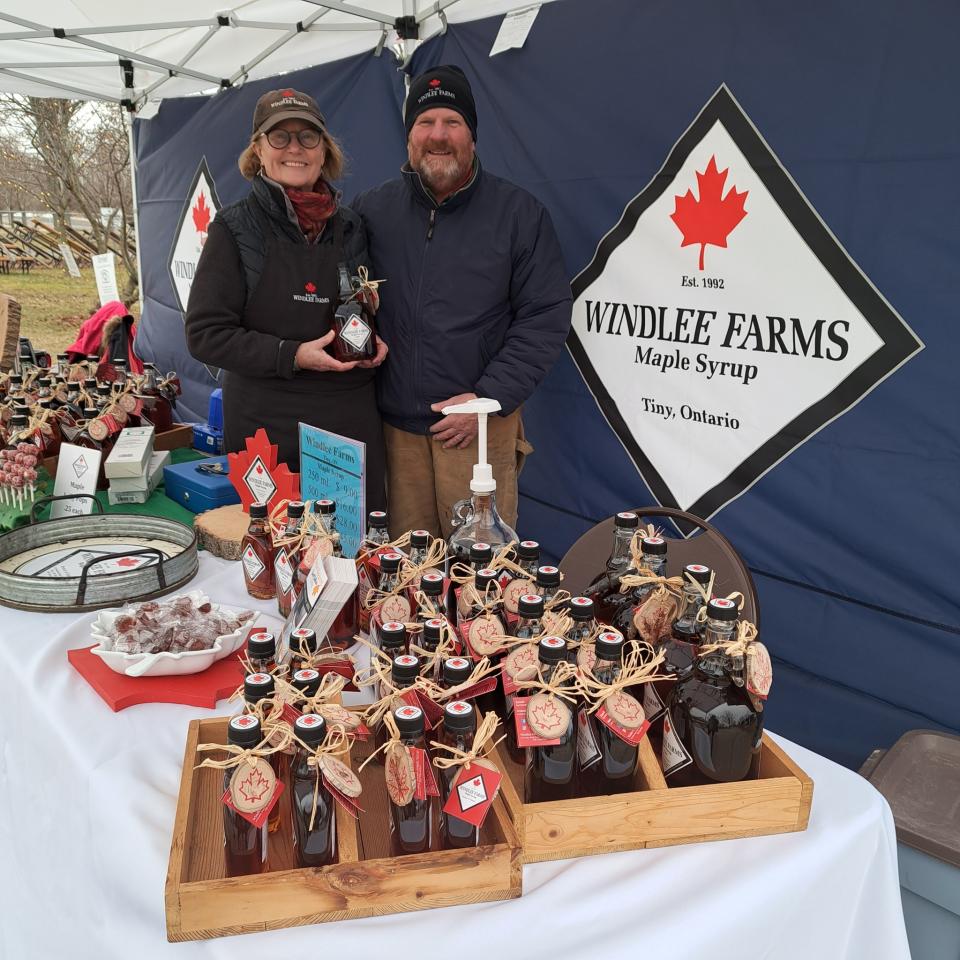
left=569, top=86, right=923, bottom=517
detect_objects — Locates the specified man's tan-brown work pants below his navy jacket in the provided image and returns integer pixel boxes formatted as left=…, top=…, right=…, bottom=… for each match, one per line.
left=383, top=410, right=533, bottom=538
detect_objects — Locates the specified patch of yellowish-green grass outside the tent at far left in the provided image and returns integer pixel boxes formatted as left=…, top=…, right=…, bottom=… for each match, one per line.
left=0, top=267, right=140, bottom=356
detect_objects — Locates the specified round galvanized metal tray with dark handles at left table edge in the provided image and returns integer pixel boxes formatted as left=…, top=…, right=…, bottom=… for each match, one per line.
left=0, top=497, right=199, bottom=613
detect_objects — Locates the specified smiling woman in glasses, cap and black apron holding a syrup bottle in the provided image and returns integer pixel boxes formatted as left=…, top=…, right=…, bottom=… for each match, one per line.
left=186, top=90, right=387, bottom=510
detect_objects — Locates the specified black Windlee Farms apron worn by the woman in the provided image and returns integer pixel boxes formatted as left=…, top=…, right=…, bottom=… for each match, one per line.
left=223, top=214, right=386, bottom=522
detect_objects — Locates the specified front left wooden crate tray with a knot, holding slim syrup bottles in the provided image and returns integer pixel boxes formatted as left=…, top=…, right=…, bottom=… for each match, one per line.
left=165, top=717, right=522, bottom=941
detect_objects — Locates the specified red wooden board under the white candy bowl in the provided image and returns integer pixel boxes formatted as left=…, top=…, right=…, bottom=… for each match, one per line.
left=67, top=647, right=246, bottom=713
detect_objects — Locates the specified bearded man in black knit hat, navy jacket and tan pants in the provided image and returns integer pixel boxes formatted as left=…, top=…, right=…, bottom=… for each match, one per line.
left=353, top=66, right=571, bottom=536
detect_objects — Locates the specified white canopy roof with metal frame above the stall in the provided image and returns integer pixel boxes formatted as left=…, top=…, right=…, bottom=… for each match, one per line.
left=0, top=0, right=549, bottom=112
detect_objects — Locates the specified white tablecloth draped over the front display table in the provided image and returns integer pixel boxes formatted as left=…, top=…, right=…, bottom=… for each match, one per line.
left=0, top=555, right=909, bottom=960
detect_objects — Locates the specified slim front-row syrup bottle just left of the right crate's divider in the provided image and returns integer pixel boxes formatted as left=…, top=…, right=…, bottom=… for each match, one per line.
left=578, top=630, right=638, bottom=796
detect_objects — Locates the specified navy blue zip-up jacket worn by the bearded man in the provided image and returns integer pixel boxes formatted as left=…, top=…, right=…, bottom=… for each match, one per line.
left=351, top=161, right=571, bottom=433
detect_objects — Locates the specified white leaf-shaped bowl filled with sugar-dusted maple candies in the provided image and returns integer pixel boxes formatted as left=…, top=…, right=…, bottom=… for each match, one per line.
left=90, top=590, right=258, bottom=677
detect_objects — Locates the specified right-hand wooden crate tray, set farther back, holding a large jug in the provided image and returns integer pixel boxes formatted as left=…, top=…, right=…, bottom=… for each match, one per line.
left=498, top=735, right=813, bottom=863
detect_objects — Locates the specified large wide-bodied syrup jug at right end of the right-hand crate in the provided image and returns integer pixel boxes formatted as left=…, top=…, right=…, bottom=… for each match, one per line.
left=661, top=598, right=763, bottom=786
